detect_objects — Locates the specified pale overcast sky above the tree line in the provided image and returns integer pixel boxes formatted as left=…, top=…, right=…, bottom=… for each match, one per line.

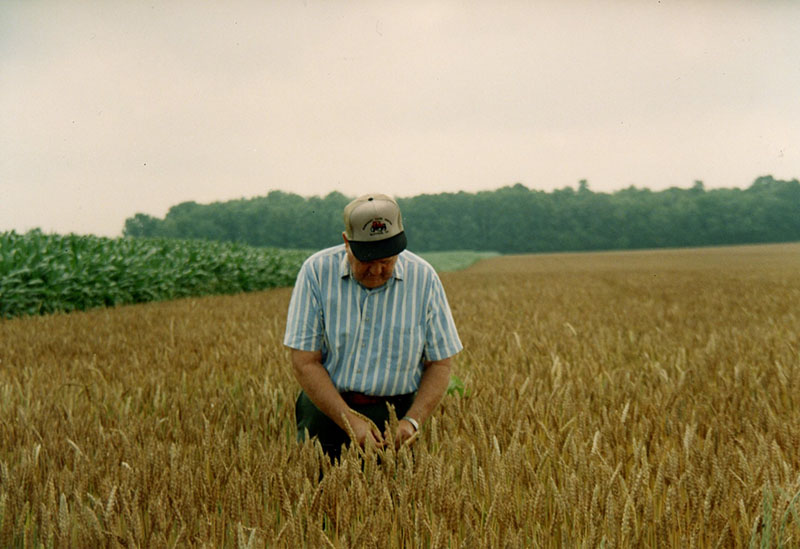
left=0, top=0, right=800, bottom=236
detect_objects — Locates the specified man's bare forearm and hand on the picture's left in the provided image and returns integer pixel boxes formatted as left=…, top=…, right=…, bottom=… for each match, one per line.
left=291, top=349, right=384, bottom=446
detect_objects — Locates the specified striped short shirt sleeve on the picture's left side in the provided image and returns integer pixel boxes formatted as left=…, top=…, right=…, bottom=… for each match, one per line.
left=283, top=261, right=324, bottom=351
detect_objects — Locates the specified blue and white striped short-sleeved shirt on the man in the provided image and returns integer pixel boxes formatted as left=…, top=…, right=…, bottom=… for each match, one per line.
left=283, top=244, right=463, bottom=396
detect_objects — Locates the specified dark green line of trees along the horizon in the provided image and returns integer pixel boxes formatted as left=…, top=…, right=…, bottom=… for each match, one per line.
left=123, top=176, right=800, bottom=253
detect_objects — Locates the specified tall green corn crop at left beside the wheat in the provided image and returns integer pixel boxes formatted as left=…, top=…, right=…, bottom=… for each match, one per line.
left=0, top=231, right=308, bottom=318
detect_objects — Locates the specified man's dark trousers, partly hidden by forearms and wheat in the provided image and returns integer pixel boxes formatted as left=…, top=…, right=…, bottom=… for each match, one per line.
left=294, top=391, right=414, bottom=462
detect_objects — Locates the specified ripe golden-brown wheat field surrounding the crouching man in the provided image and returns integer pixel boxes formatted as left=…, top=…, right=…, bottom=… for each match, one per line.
left=0, top=244, right=800, bottom=548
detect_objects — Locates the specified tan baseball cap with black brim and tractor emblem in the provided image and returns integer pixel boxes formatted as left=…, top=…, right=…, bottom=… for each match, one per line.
left=344, top=194, right=407, bottom=261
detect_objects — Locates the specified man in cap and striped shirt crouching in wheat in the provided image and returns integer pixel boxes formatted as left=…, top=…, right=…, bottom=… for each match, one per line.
left=283, top=194, right=463, bottom=459
